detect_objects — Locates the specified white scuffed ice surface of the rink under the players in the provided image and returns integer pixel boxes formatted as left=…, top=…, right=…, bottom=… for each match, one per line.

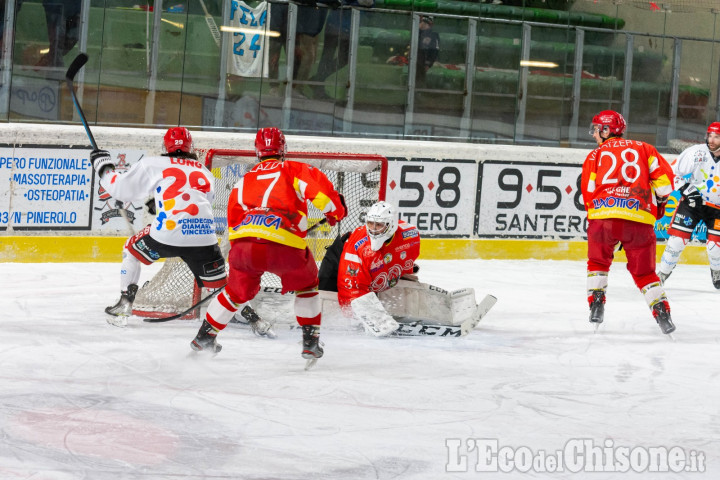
left=0, top=260, right=720, bottom=480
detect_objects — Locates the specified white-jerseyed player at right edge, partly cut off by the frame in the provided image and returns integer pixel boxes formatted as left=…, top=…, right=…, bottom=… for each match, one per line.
left=658, top=122, right=720, bottom=289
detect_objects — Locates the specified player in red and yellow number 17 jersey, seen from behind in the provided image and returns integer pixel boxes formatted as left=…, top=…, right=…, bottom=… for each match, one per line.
left=191, top=127, right=346, bottom=361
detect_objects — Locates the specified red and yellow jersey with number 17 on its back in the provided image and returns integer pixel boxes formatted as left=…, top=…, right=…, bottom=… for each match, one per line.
left=228, top=159, right=345, bottom=249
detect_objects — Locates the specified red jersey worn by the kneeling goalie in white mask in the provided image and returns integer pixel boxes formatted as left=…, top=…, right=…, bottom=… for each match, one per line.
left=338, top=220, right=420, bottom=306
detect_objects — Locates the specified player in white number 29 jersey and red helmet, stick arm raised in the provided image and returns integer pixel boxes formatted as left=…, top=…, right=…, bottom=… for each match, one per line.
left=90, top=127, right=226, bottom=326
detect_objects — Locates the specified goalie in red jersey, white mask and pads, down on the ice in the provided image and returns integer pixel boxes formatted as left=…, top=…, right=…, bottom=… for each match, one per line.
left=320, top=202, right=495, bottom=336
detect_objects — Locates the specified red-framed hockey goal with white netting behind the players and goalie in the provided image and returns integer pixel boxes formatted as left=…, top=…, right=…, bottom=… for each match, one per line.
left=133, top=150, right=387, bottom=318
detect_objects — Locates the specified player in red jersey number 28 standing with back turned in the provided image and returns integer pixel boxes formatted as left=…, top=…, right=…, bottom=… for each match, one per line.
left=581, top=110, right=675, bottom=333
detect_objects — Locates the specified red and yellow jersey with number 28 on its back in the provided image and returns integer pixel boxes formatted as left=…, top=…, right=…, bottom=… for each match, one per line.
left=581, top=137, right=674, bottom=225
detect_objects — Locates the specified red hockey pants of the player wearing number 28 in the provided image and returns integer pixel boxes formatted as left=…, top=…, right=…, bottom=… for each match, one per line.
left=588, top=218, right=660, bottom=288
